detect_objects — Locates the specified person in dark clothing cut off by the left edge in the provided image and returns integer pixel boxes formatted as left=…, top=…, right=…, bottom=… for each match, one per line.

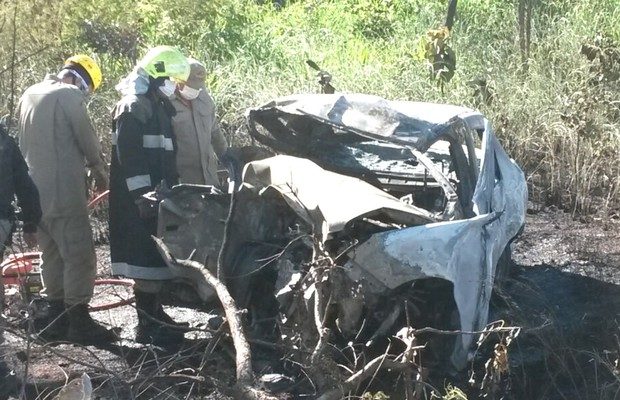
left=0, top=122, right=41, bottom=342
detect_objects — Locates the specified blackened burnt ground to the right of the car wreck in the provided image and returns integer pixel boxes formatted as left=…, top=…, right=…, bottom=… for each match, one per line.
left=490, top=208, right=620, bottom=399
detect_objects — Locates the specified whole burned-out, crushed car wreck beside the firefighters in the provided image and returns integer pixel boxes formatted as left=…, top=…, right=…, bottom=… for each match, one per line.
left=159, top=94, right=527, bottom=369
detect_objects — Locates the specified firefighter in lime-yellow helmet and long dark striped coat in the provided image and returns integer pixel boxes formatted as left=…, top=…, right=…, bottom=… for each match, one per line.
left=110, top=46, right=190, bottom=345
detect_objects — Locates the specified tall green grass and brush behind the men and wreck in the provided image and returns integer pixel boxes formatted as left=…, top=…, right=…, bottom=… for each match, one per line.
left=0, top=0, right=620, bottom=212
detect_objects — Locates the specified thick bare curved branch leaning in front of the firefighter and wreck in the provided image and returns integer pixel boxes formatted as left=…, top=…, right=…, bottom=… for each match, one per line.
left=153, top=237, right=272, bottom=400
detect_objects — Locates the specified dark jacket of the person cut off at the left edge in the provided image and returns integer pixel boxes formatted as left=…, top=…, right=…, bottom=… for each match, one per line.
left=0, top=124, right=41, bottom=232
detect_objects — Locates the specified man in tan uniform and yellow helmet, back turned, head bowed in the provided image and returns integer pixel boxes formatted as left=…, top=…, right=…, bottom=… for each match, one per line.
left=19, top=55, right=118, bottom=344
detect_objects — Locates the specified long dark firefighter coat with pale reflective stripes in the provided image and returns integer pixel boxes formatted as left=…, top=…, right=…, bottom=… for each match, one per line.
left=109, top=92, right=178, bottom=280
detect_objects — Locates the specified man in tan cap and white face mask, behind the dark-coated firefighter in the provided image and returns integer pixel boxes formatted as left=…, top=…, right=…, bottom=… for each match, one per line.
left=172, top=58, right=228, bottom=186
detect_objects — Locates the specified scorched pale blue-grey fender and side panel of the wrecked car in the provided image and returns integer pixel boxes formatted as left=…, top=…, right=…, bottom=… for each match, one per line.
left=349, top=122, right=527, bottom=367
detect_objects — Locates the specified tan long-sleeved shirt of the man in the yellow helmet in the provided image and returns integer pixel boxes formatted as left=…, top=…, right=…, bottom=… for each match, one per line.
left=18, top=75, right=105, bottom=218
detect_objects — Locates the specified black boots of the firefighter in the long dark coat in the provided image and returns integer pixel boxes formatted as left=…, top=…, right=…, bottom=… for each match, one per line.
left=134, top=290, right=184, bottom=346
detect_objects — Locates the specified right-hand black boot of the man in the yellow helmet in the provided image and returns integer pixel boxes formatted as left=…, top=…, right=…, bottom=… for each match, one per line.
left=66, top=304, right=119, bottom=346
